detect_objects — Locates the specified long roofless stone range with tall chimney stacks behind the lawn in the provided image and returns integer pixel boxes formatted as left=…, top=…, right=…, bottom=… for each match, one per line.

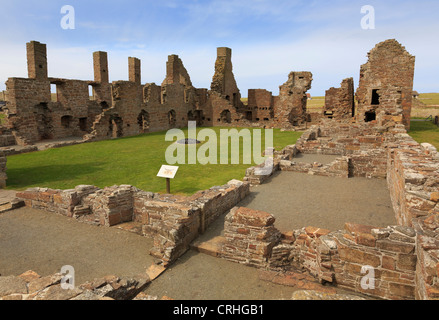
left=0, top=41, right=312, bottom=151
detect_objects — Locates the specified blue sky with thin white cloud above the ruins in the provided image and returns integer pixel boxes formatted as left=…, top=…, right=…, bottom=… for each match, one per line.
left=0, top=0, right=439, bottom=97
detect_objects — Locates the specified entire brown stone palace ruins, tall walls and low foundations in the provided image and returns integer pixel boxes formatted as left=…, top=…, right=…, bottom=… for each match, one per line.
left=2, top=40, right=439, bottom=300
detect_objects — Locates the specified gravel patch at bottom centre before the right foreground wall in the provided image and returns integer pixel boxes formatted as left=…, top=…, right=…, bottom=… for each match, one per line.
left=145, top=251, right=304, bottom=300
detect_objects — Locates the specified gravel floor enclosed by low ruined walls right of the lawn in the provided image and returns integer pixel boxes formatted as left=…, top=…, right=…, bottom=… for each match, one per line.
left=238, top=172, right=396, bottom=231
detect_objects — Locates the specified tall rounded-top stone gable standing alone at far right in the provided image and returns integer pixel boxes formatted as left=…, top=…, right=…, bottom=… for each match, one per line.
left=356, top=39, right=415, bottom=129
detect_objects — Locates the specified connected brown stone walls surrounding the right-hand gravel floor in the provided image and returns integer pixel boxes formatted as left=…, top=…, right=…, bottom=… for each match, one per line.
left=215, top=121, right=439, bottom=300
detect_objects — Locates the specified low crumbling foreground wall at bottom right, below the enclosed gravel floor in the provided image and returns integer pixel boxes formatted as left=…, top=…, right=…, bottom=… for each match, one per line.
left=217, top=208, right=432, bottom=300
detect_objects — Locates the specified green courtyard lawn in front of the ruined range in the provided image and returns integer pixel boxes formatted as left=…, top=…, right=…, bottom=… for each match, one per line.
left=7, top=128, right=302, bottom=194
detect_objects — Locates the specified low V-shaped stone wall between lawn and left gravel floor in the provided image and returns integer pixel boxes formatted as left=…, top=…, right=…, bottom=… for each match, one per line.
left=16, top=180, right=250, bottom=265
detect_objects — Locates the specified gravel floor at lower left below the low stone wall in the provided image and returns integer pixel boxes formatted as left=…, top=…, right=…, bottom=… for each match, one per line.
left=0, top=208, right=153, bottom=284
